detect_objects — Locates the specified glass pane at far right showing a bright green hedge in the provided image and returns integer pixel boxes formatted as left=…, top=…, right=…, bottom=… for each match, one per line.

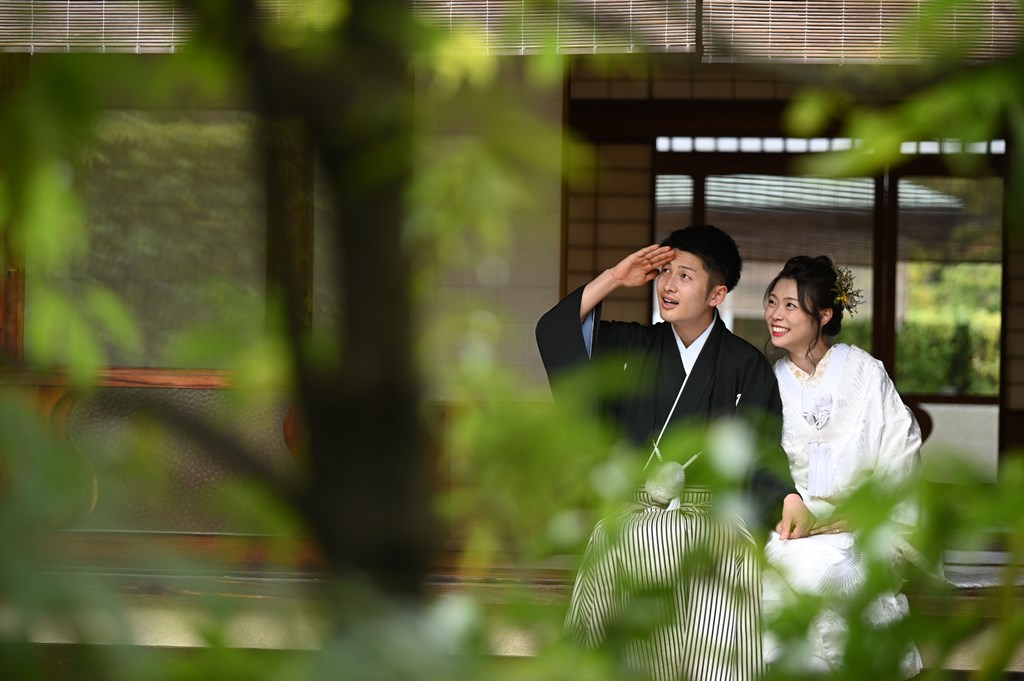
left=895, top=177, right=1002, bottom=396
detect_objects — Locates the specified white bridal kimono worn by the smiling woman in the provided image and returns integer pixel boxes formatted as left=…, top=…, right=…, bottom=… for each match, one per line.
left=764, top=344, right=922, bottom=678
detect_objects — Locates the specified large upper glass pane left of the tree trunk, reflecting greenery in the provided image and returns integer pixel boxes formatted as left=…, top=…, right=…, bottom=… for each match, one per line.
left=25, top=111, right=266, bottom=368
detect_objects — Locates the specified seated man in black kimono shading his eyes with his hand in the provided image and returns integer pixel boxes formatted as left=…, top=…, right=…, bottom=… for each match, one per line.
left=537, top=225, right=813, bottom=681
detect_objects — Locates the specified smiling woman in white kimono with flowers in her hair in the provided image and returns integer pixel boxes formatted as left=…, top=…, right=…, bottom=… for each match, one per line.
left=764, top=256, right=921, bottom=678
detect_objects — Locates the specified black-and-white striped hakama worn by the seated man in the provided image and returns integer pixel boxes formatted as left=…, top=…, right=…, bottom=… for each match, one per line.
left=565, top=488, right=764, bottom=681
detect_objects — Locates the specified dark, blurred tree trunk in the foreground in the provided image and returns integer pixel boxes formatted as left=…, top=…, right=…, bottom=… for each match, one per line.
left=187, top=0, right=435, bottom=595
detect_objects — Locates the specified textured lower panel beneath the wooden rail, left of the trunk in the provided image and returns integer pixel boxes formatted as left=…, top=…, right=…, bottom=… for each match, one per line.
left=68, top=388, right=295, bottom=533
